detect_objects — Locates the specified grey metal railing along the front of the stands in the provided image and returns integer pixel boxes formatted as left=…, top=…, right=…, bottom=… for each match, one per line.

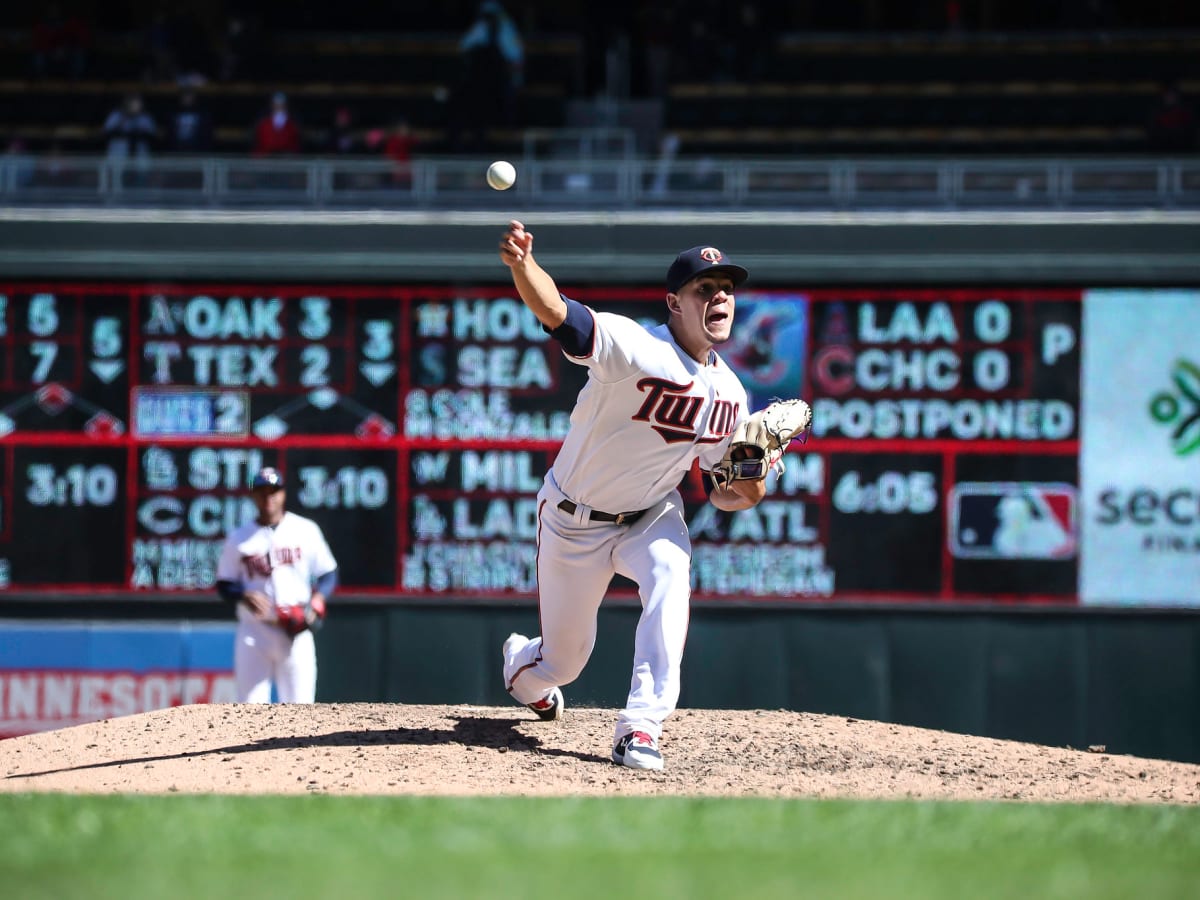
left=0, top=156, right=1200, bottom=210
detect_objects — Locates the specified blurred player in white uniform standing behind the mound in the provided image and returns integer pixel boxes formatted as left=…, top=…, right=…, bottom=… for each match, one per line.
left=217, top=468, right=337, bottom=703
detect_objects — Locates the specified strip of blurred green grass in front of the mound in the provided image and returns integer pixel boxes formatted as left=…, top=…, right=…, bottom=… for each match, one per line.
left=0, top=794, right=1200, bottom=900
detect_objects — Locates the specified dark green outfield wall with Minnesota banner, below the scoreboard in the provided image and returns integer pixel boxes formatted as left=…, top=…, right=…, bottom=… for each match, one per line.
left=0, top=601, right=1200, bottom=762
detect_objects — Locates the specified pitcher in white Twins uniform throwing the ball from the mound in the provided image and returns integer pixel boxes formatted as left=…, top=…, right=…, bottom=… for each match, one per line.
left=500, top=221, right=766, bottom=769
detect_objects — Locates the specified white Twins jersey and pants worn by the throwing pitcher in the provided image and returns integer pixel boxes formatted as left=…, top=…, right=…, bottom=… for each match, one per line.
left=503, top=312, right=748, bottom=743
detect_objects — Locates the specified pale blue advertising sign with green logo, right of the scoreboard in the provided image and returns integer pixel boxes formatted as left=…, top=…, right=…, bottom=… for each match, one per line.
left=1079, top=290, right=1200, bottom=606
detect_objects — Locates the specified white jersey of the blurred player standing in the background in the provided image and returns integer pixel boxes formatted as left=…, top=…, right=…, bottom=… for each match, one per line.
left=217, top=512, right=337, bottom=619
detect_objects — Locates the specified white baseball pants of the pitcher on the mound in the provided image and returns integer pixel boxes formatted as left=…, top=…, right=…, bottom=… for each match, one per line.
left=504, top=479, right=691, bottom=740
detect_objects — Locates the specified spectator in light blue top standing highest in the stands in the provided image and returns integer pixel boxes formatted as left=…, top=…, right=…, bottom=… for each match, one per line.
left=450, top=0, right=524, bottom=150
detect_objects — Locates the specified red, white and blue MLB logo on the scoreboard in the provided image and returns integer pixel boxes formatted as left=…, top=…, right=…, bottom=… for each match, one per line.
left=949, top=481, right=1079, bottom=559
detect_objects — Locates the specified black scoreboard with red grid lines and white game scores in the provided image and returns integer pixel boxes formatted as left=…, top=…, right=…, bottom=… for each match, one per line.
left=0, top=282, right=1081, bottom=602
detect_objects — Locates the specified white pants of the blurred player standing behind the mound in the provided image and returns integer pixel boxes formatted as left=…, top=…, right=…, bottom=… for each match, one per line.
left=233, top=618, right=317, bottom=703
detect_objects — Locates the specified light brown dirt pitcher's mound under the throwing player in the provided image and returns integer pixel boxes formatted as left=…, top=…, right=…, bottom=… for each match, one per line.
left=0, top=703, right=1200, bottom=804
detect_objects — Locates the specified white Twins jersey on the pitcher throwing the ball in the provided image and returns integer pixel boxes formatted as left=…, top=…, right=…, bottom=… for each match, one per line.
left=552, top=312, right=749, bottom=512
